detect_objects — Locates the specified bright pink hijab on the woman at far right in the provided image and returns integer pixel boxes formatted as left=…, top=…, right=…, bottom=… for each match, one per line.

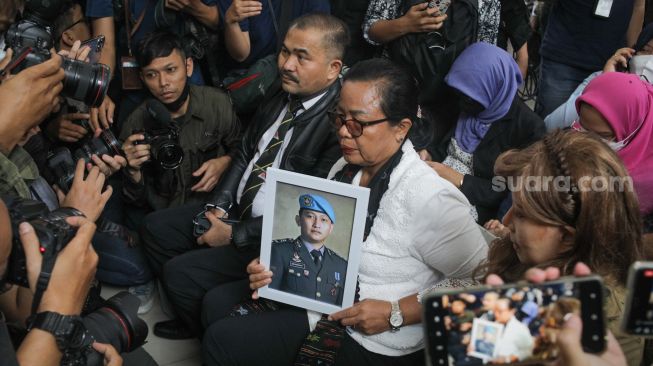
left=576, top=72, right=653, bottom=214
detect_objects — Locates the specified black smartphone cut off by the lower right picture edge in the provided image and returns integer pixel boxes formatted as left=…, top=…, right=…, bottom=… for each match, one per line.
left=621, top=262, right=653, bottom=337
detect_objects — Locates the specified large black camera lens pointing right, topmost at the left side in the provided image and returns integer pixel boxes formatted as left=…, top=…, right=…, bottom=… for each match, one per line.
left=62, top=58, right=111, bottom=107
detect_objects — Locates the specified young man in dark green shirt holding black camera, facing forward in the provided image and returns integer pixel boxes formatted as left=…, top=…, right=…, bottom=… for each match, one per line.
left=120, top=32, right=239, bottom=210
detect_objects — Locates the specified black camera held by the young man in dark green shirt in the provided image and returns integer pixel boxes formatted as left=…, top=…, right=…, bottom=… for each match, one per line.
left=135, top=125, right=184, bottom=170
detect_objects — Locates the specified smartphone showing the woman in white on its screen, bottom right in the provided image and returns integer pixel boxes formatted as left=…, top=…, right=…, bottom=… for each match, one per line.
left=423, top=276, right=606, bottom=366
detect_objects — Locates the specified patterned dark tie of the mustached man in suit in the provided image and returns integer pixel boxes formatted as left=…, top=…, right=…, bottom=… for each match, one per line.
left=239, top=99, right=303, bottom=220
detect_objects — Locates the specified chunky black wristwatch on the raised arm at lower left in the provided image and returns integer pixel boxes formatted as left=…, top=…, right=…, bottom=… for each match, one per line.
left=27, top=311, right=92, bottom=352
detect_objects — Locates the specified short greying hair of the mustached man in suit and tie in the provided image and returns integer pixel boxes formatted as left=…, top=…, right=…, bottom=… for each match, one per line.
left=288, top=13, right=350, bottom=60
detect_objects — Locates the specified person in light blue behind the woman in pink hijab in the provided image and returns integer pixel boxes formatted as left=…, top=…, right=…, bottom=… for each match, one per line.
left=544, top=24, right=653, bottom=131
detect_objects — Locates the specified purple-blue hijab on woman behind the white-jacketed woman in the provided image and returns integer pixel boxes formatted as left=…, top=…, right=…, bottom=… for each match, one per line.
left=444, top=42, right=522, bottom=154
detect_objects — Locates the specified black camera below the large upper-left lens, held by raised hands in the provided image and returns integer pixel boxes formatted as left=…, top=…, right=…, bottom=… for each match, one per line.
left=47, top=130, right=125, bottom=193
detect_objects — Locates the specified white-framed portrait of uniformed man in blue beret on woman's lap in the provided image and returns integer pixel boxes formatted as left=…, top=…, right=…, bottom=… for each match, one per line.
left=259, top=168, right=369, bottom=314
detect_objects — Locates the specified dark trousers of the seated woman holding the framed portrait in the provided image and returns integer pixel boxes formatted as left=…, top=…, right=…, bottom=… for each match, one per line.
left=202, top=280, right=424, bottom=366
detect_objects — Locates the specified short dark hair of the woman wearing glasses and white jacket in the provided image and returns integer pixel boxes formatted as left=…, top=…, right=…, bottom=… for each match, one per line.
left=343, top=58, right=419, bottom=125
